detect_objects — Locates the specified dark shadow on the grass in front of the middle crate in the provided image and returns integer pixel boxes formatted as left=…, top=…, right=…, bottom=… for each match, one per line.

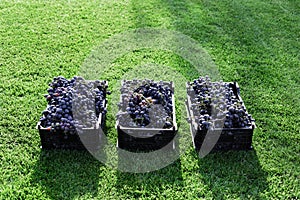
left=115, top=160, right=184, bottom=199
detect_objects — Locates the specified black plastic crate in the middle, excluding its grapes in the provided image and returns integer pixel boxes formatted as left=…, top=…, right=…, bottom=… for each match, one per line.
left=116, top=81, right=177, bottom=152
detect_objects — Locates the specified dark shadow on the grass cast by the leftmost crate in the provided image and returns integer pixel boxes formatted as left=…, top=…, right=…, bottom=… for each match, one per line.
left=31, top=150, right=102, bottom=199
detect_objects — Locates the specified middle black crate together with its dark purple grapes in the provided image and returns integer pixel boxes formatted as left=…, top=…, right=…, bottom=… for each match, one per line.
left=116, top=80, right=177, bottom=152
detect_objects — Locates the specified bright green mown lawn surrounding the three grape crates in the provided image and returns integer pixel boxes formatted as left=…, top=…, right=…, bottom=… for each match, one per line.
left=0, top=0, right=300, bottom=199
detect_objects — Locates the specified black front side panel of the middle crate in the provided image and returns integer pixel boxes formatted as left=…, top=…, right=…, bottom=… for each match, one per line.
left=117, top=127, right=177, bottom=152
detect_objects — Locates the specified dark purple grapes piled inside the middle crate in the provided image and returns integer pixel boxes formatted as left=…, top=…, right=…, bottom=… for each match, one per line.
left=119, top=80, right=173, bottom=128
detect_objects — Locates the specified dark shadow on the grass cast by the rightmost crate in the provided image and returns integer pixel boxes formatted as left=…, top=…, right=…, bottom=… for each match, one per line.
left=195, top=150, right=268, bottom=199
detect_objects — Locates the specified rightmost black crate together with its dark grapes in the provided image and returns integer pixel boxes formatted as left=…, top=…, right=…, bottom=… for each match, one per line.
left=186, top=76, right=255, bottom=151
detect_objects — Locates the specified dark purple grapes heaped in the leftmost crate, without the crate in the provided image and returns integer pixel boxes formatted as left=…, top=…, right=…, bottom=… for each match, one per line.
left=40, top=76, right=107, bottom=134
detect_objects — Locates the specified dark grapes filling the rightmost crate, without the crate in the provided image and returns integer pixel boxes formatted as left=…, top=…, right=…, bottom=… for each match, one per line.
left=189, top=76, right=253, bottom=130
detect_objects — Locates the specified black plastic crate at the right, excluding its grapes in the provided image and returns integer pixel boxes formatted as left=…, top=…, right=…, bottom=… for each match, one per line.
left=186, top=82, right=256, bottom=151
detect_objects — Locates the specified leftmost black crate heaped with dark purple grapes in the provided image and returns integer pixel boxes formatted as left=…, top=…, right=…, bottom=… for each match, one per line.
left=37, top=76, right=109, bottom=150
